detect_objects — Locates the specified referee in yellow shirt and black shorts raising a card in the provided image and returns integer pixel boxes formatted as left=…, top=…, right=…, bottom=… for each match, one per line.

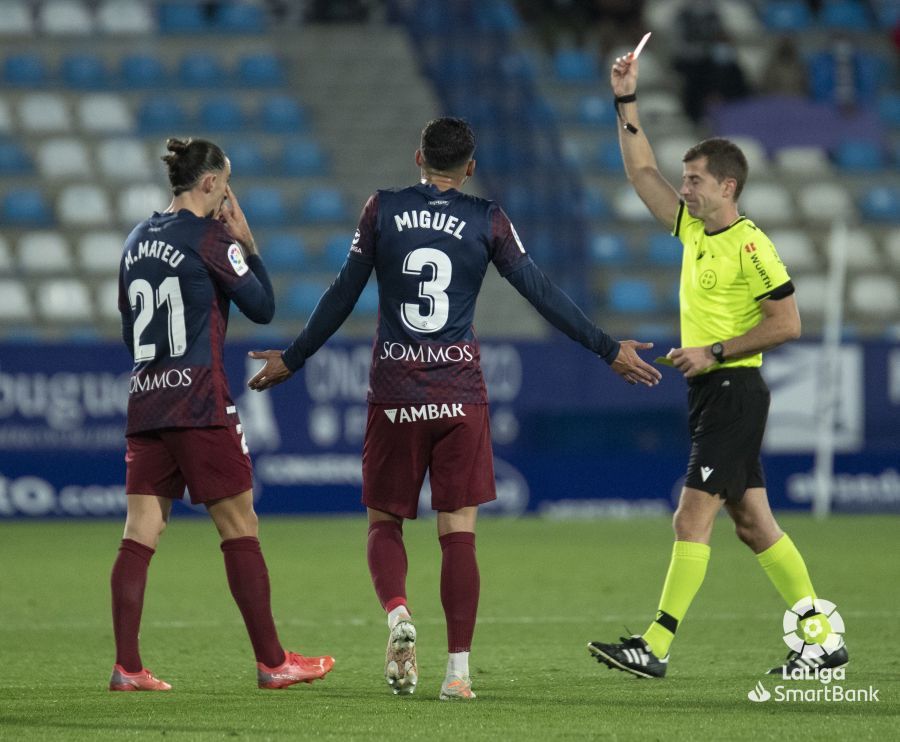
left=588, top=48, right=847, bottom=678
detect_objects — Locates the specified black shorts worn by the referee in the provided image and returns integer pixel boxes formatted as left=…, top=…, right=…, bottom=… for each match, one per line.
left=685, top=368, right=769, bottom=500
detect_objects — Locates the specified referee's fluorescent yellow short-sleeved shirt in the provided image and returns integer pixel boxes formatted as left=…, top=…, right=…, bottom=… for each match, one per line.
left=672, top=202, right=791, bottom=370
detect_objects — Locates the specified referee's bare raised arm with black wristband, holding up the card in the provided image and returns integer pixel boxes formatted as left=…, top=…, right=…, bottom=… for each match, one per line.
left=610, top=53, right=680, bottom=229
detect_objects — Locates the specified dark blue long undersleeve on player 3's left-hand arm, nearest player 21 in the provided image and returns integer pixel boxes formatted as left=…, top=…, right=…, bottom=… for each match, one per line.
left=281, top=255, right=372, bottom=371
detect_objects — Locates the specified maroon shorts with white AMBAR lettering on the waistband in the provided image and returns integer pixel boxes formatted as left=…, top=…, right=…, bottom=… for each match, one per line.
left=362, top=403, right=497, bottom=518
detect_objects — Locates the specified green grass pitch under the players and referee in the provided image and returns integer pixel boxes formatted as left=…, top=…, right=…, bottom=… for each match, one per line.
left=0, top=516, right=900, bottom=742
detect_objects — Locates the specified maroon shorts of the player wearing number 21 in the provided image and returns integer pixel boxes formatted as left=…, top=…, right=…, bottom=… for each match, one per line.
left=125, top=425, right=253, bottom=505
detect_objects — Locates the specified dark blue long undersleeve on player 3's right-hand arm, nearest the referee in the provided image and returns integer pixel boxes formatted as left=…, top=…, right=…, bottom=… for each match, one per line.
left=505, top=262, right=619, bottom=363
